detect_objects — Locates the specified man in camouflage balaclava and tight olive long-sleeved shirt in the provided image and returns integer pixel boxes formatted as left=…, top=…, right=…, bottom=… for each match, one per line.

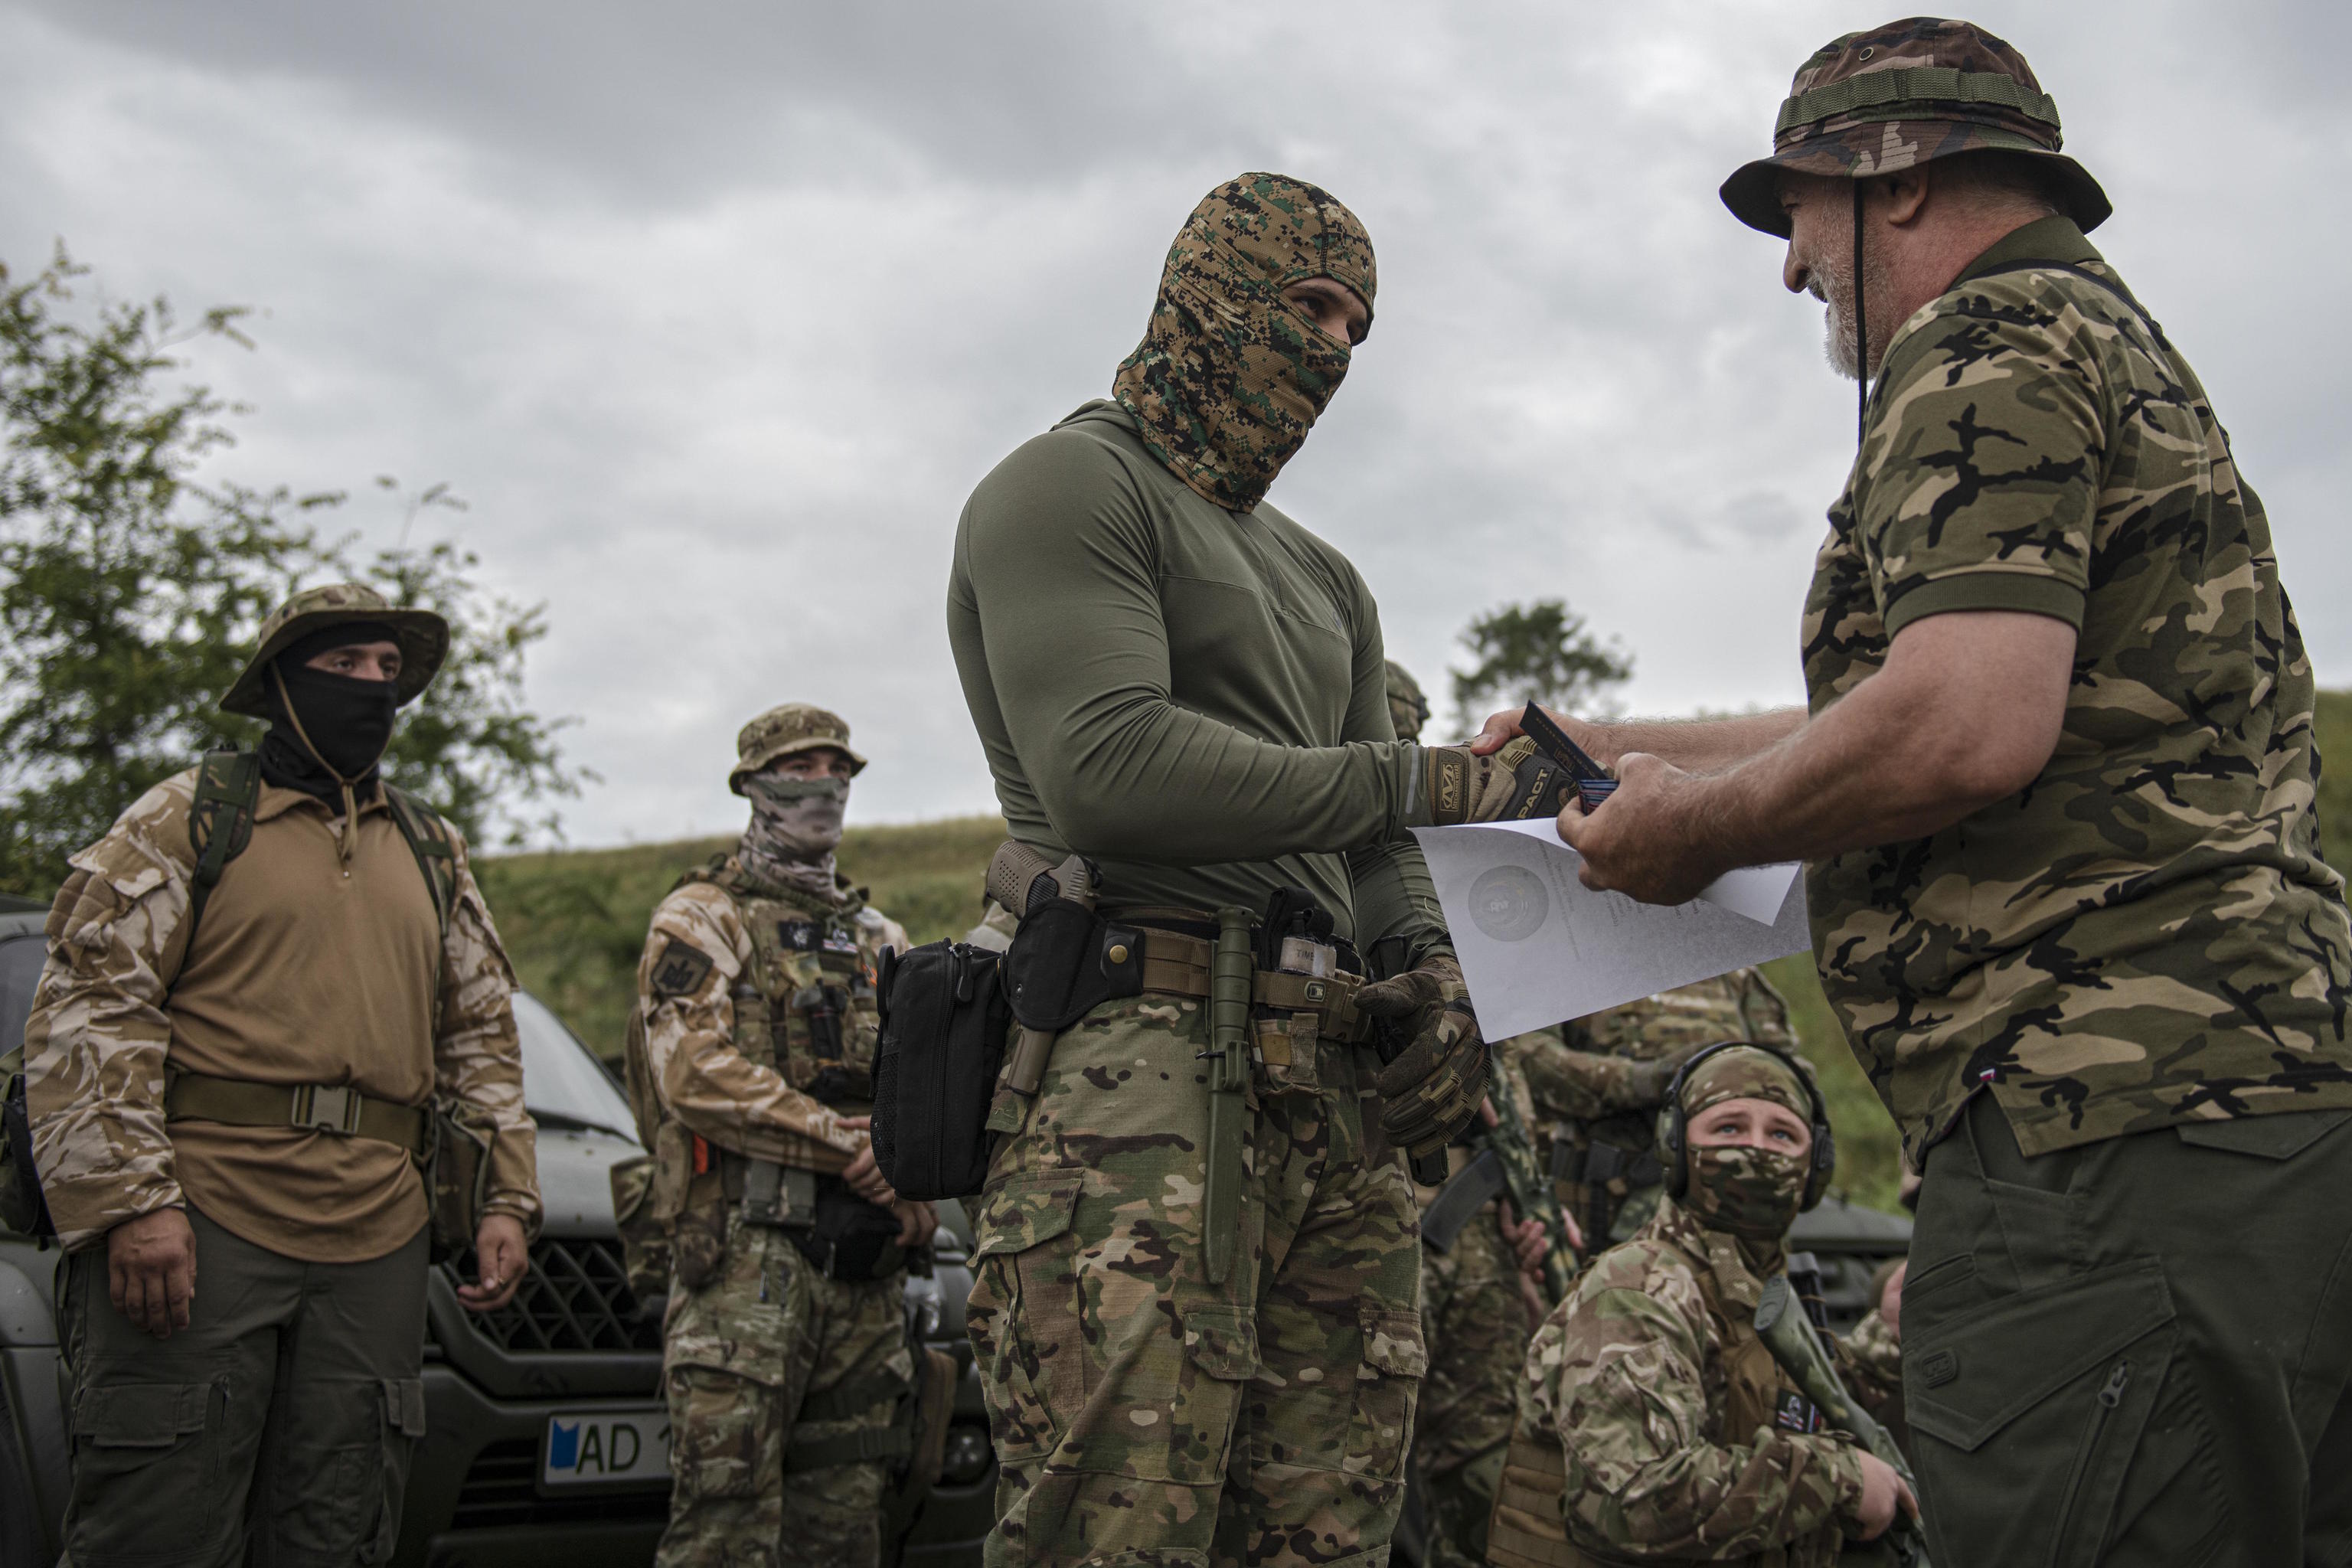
left=948, top=174, right=1522, bottom=1563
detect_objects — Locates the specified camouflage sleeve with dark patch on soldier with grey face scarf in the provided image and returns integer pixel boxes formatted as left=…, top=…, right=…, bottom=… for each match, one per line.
left=638, top=884, right=865, bottom=1173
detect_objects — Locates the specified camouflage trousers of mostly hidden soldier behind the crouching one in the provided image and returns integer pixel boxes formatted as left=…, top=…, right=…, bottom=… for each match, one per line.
left=1413, top=1210, right=1534, bottom=1568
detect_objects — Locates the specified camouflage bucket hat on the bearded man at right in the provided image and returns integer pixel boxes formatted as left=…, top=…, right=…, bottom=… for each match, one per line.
left=1722, top=16, right=2115, bottom=240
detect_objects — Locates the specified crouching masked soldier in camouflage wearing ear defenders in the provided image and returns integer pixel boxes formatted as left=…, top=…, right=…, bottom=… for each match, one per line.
left=1489, top=1046, right=1907, bottom=1568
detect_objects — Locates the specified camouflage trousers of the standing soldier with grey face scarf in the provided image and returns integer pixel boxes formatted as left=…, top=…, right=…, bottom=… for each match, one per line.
left=654, top=1218, right=915, bottom=1568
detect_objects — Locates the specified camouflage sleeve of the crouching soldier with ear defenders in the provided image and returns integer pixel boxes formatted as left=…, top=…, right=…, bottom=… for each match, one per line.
left=1555, top=1279, right=1863, bottom=1559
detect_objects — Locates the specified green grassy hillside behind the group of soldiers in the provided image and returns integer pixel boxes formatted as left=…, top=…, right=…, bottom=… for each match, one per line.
left=480, top=691, right=2352, bottom=1206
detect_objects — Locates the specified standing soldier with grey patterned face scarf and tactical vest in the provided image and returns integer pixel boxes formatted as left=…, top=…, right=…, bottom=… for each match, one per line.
left=628, top=703, right=936, bottom=1568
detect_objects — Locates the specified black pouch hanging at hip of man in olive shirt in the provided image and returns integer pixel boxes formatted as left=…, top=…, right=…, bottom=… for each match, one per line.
left=873, top=942, right=1011, bottom=1204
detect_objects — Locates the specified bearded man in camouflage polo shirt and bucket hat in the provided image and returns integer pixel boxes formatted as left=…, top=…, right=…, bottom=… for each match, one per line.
left=1484, top=19, right=2352, bottom=1568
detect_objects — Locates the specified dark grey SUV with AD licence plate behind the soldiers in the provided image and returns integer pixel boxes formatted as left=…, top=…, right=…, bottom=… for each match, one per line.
left=0, top=898, right=995, bottom=1568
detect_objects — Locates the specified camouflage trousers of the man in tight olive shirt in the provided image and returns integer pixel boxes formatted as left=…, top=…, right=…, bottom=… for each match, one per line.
left=969, top=995, right=1426, bottom=1568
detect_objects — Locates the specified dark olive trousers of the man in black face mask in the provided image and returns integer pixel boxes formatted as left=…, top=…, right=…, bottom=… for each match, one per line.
left=59, top=1208, right=426, bottom=1568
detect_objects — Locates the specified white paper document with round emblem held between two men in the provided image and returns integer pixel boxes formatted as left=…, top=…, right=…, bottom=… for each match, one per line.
left=1413, top=818, right=1814, bottom=1039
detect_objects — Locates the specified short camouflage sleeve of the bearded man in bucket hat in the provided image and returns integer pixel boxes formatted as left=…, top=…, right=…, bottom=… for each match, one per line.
left=1856, top=277, right=2108, bottom=637
